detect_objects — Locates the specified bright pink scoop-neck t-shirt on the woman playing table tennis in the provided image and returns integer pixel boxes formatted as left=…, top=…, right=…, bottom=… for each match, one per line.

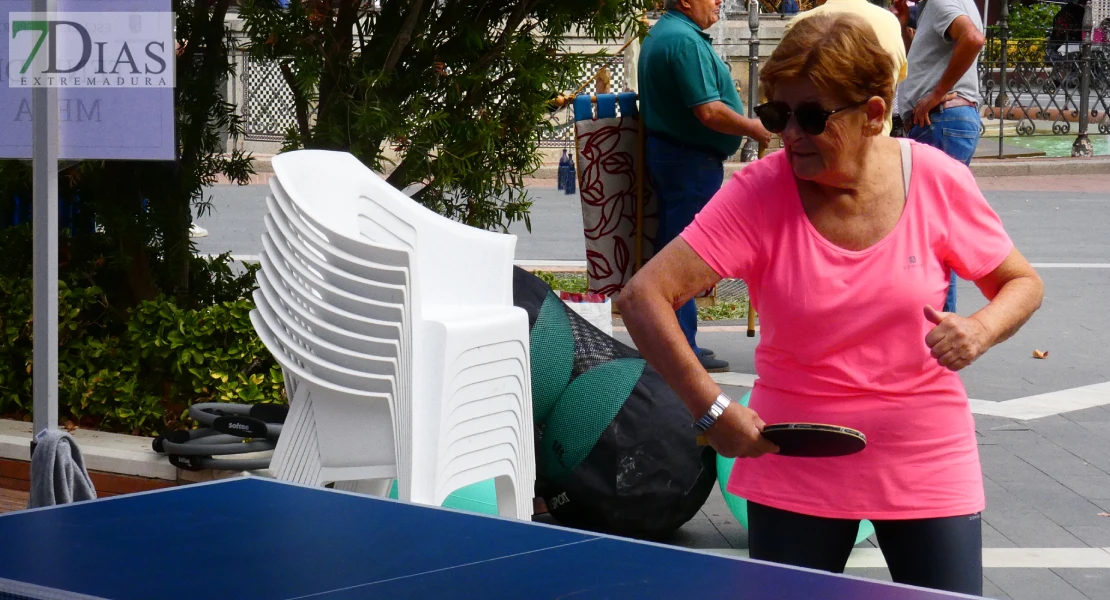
left=682, top=143, right=1013, bottom=520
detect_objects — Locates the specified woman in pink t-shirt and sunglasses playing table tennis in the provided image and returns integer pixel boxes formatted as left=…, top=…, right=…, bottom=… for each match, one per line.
left=618, top=14, right=1043, bottom=594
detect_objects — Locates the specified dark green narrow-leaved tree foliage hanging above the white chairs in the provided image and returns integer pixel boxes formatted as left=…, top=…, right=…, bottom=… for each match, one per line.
left=240, top=0, right=655, bottom=228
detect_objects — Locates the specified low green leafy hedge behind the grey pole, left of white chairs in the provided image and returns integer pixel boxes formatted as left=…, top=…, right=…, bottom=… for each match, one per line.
left=0, top=224, right=285, bottom=435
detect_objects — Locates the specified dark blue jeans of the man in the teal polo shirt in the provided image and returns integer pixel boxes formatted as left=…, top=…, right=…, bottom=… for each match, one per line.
left=647, top=135, right=725, bottom=354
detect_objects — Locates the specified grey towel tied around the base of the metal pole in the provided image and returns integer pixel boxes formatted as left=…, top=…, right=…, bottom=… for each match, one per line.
left=27, top=429, right=97, bottom=508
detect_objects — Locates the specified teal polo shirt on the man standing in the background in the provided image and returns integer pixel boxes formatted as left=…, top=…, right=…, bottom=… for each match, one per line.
left=637, top=10, right=744, bottom=156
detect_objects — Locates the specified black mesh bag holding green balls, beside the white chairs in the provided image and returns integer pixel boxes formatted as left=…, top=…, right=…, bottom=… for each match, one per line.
left=514, top=268, right=717, bottom=540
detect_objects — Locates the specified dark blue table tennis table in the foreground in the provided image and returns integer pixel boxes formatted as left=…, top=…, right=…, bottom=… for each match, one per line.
left=0, top=477, right=970, bottom=600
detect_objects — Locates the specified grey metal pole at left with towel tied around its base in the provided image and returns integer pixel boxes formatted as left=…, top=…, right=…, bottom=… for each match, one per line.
left=31, top=0, right=58, bottom=439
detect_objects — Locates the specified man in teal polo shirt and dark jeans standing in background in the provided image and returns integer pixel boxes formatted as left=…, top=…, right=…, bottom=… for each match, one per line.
left=637, top=0, right=770, bottom=373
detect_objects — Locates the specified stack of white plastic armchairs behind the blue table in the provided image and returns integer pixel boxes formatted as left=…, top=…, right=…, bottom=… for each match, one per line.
left=251, top=151, right=535, bottom=519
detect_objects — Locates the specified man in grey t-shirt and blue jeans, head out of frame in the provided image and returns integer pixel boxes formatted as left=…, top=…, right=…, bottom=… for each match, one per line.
left=892, top=0, right=987, bottom=313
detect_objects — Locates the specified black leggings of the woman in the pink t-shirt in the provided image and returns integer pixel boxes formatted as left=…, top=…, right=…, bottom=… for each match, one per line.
left=748, top=501, right=982, bottom=596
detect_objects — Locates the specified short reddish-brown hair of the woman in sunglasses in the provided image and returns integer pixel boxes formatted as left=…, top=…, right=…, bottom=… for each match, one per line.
left=759, top=13, right=895, bottom=113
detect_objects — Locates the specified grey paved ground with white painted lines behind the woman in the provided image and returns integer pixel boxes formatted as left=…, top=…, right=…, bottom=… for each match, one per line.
left=198, top=170, right=1110, bottom=600
